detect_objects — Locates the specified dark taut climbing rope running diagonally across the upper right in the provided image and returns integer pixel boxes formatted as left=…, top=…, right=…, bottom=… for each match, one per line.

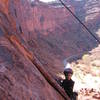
left=59, top=0, right=100, bottom=43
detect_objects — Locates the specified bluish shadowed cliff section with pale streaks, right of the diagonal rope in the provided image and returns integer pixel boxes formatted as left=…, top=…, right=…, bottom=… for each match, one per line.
left=65, top=0, right=100, bottom=37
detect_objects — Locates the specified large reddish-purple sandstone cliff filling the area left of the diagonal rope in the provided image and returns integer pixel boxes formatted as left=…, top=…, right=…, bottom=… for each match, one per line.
left=0, top=0, right=98, bottom=100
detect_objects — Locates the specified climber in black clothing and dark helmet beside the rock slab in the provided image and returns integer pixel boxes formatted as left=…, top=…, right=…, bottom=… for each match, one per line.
left=61, top=68, right=78, bottom=100
